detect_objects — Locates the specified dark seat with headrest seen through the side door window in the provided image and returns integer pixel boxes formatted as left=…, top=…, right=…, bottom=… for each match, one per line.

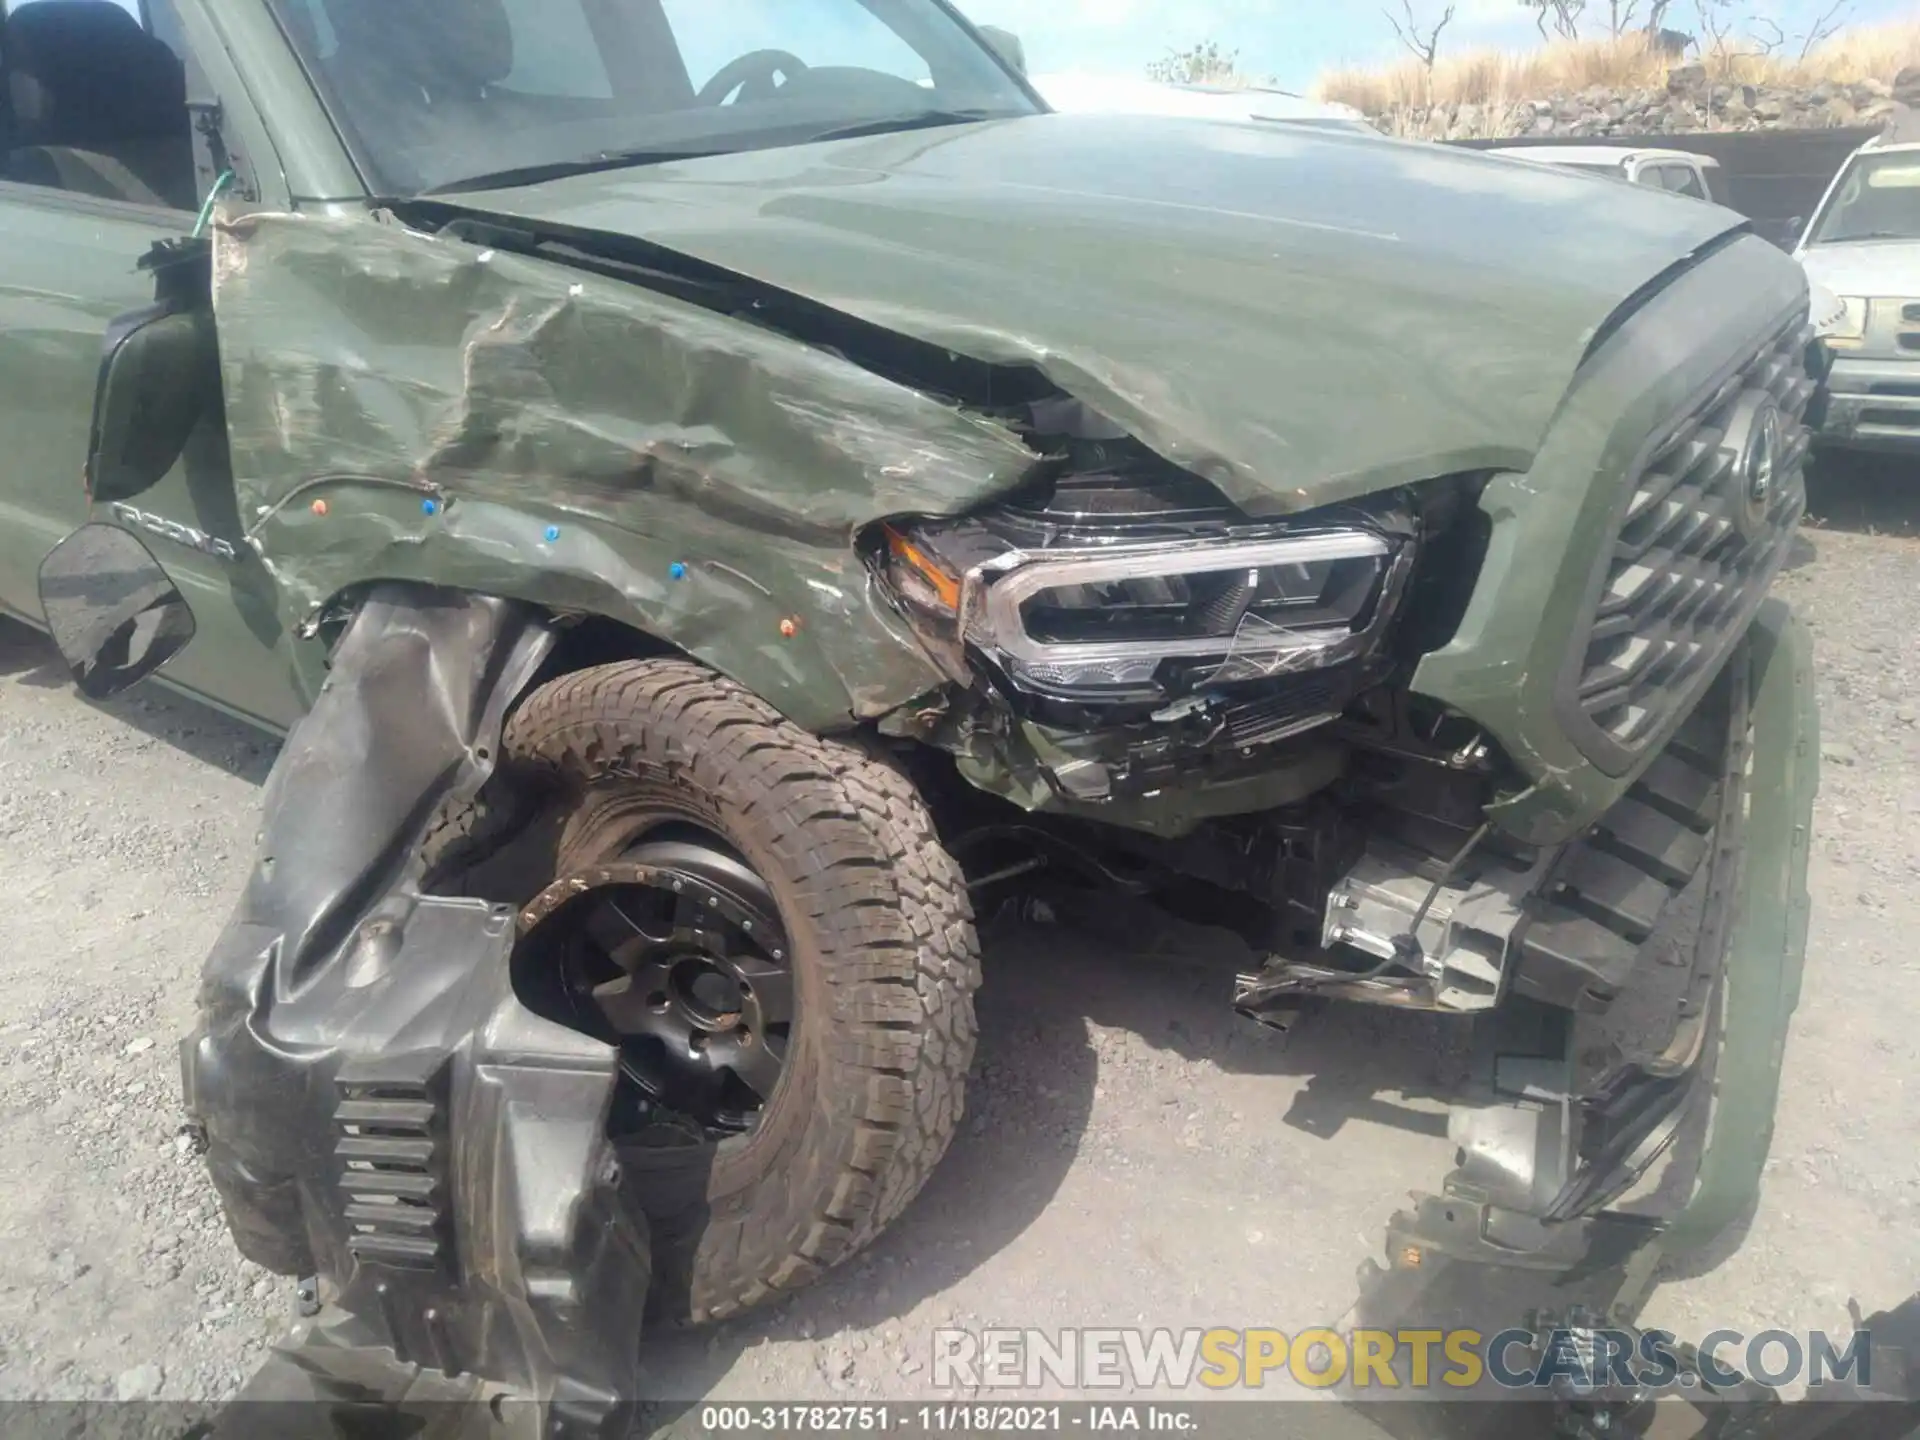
left=0, top=0, right=188, bottom=148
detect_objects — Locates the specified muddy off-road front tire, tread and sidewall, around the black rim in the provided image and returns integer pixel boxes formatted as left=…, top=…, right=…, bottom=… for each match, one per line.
left=503, top=660, right=979, bottom=1323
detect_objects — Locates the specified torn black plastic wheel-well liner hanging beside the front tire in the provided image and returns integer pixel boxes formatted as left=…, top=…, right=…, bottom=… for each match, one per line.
left=182, top=586, right=649, bottom=1430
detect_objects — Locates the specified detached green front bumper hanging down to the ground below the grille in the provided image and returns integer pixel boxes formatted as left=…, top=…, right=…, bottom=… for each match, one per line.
left=1359, top=601, right=1818, bottom=1329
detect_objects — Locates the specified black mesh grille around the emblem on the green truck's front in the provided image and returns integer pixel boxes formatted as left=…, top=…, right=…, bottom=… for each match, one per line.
left=1578, top=319, right=1814, bottom=753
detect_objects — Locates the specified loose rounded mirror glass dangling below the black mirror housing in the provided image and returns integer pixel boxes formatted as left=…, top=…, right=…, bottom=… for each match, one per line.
left=40, top=524, right=194, bottom=701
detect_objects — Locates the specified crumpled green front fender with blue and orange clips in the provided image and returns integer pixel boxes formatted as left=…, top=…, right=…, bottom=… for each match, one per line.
left=213, top=215, right=1039, bottom=730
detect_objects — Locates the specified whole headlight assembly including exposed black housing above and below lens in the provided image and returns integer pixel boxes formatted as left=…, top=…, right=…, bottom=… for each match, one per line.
left=877, top=401, right=1423, bottom=802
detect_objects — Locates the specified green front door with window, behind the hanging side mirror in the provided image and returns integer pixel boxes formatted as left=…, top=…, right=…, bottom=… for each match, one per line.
left=0, top=0, right=303, bottom=728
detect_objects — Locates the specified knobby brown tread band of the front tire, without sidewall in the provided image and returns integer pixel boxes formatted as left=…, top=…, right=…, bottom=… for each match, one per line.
left=505, top=659, right=979, bottom=1323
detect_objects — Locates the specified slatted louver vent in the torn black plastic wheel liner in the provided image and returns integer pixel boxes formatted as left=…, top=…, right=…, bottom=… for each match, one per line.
left=334, top=1079, right=447, bottom=1269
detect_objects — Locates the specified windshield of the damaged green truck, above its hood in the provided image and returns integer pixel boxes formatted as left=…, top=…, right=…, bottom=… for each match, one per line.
left=273, top=0, right=1037, bottom=196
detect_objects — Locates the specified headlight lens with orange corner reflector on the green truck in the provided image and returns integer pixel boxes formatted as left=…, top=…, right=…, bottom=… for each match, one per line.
left=887, top=520, right=1409, bottom=701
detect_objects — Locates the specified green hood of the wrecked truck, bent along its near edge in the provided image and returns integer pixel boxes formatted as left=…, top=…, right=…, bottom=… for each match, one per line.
left=461, top=115, right=1741, bottom=513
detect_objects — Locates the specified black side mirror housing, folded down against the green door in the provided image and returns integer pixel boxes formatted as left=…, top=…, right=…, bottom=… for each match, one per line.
left=86, top=242, right=221, bottom=505
